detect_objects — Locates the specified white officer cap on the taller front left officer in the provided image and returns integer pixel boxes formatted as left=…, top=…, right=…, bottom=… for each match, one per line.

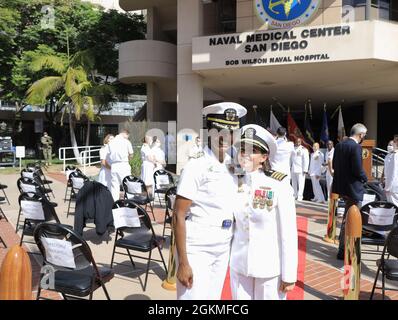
left=202, top=102, right=247, bottom=130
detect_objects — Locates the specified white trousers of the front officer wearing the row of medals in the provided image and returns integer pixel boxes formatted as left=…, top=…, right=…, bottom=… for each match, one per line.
left=230, top=269, right=286, bottom=300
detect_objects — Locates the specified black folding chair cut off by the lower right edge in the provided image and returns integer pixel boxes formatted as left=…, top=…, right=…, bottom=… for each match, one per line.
left=370, top=227, right=398, bottom=300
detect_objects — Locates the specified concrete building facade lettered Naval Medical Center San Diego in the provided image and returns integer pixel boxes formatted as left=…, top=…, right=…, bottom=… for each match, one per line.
left=119, top=0, right=398, bottom=168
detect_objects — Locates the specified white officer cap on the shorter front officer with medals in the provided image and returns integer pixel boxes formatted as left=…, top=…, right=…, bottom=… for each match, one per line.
left=239, top=124, right=277, bottom=157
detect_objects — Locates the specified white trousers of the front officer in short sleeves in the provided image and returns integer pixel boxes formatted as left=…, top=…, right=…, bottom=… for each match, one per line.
left=177, top=242, right=230, bottom=300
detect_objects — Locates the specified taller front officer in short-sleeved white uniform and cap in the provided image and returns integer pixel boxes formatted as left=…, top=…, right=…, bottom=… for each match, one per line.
left=173, top=102, right=247, bottom=300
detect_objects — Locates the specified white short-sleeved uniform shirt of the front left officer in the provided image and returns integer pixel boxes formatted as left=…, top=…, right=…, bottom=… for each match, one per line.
left=177, top=147, right=237, bottom=246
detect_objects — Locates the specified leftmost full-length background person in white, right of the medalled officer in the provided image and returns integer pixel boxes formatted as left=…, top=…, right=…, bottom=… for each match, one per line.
left=292, top=138, right=310, bottom=201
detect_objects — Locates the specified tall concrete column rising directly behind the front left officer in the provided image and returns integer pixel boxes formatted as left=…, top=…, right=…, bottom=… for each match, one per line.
left=177, top=0, right=203, bottom=173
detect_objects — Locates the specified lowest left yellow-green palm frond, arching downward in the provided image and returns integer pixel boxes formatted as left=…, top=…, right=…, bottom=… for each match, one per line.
left=25, top=76, right=64, bottom=105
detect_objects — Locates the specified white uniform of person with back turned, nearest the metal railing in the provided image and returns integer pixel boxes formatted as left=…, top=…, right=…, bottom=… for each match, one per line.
left=108, top=134, right=134, bottom=201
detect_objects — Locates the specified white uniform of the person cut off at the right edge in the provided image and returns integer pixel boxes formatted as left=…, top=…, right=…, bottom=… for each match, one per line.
left=384, top=150, right=398, bottom=206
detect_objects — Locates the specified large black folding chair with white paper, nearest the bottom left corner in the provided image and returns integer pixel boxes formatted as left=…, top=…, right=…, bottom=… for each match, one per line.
left=34, top=222, right=114, bottom=300
